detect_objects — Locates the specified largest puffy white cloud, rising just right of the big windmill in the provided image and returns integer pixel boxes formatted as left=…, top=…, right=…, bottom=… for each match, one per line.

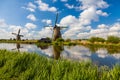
left=60, top=7, right=98, bottom=38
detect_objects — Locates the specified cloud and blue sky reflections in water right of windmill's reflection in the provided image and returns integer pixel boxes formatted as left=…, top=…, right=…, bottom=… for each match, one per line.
left=62, top=46, right=120, bottom=67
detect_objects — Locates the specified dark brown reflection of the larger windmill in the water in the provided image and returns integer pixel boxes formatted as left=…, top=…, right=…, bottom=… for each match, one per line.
left=53, top=45, right=64, bottom=60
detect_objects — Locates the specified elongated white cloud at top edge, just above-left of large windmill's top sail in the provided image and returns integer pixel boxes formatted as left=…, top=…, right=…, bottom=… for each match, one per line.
left=36, top=0, right=57, bottom=12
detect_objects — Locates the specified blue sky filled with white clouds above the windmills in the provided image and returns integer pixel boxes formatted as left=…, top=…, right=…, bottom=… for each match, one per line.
left=0, top=0, right=120, bottom=39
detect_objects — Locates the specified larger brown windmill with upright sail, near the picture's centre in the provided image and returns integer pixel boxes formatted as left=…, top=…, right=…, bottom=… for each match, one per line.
left=44, top=13, right=67, bottom=41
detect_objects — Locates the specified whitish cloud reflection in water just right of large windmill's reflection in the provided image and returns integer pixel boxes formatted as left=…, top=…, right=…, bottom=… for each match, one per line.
left=61, top=46, right=91, bottom=61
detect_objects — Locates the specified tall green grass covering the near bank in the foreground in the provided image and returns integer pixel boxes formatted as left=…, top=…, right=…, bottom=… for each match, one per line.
left=0, top=50, right=120, bottom=80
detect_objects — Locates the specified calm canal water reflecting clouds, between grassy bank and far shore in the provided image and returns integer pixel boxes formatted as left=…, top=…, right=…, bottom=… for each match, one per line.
left=0, top=43, right=120, bottom=67
